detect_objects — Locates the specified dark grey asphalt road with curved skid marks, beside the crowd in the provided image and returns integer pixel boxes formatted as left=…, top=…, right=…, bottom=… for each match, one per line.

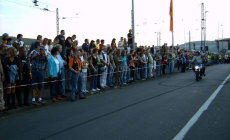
left=0, top=64, right=230, bottom=140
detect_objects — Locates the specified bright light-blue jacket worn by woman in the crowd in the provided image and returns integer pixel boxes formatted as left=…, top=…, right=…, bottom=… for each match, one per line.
left=48, top=55, right=58, bottom=77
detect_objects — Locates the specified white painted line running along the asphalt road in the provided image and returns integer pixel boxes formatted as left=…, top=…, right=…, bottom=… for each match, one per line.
left=173, top=74, right=230, bottom=140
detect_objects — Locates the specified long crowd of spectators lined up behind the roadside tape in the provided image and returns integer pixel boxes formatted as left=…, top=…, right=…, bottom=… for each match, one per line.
left=0, top=30, right=229, bottom=110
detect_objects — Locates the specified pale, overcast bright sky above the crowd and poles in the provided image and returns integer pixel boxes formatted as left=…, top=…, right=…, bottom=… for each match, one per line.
left=0, top=0, right=230, bottom=45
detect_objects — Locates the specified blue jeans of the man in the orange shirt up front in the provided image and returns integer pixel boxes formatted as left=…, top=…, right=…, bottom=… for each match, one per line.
left=70, top=73, right=83, bottom=100
